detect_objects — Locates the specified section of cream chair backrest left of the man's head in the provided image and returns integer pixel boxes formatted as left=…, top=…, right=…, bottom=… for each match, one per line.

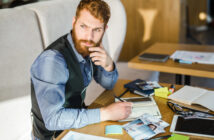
left=24, top=0, right=80, bottom=48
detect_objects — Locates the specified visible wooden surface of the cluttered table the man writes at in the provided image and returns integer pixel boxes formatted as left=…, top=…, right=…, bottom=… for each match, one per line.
left=56, top=80, right=213, bottom=140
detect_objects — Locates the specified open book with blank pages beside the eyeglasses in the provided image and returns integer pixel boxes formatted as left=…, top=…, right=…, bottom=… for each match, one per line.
left=168, top=86, right=214, bottom=111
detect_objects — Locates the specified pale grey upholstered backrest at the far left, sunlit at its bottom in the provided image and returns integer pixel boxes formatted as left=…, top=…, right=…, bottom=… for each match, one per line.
left=0, top=8, right=43, bottom=140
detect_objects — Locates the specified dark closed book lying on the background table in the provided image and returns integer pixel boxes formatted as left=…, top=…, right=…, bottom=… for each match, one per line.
left=139, top=53, right=169, bottom=62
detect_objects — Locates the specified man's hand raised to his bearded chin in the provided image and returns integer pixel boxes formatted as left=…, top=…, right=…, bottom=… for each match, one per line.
left=88, top=44, right=114, bottom=71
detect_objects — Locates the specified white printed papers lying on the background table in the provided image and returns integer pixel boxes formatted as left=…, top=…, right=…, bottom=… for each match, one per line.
left=170, top=50, right=214, bottom=64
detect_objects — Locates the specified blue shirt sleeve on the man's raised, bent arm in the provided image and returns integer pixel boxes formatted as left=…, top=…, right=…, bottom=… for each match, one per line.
left=94, top=63, right=118, bottom=89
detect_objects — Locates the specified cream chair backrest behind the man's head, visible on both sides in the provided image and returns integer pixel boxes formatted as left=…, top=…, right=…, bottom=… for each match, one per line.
left=25, top=0, right=126, bottom=61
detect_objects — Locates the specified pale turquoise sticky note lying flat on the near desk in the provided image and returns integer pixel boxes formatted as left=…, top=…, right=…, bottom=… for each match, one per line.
left=105, top=125, right=123, bottom=135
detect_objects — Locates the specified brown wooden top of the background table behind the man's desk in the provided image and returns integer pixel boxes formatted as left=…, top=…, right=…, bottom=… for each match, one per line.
left=128, top=43, right=214, bottom=78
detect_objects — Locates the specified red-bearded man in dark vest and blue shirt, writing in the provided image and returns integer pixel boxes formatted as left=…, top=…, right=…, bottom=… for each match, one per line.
left=31, top=0, right=132, bottom=140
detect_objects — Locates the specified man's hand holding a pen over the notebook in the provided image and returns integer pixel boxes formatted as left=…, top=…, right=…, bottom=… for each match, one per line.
left=100, top=102, right=132, bottom=121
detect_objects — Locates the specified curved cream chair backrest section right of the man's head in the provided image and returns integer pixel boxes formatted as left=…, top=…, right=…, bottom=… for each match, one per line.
left=102, top=0, right=127, bottom=62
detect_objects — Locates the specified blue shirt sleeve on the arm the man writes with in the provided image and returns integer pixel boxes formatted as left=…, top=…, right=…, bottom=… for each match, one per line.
left=31, top=50, right=100, bottom=130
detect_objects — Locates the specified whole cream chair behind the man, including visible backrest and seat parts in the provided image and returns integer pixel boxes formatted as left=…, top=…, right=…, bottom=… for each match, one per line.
left=27, top=0, right=157, bottom=105
